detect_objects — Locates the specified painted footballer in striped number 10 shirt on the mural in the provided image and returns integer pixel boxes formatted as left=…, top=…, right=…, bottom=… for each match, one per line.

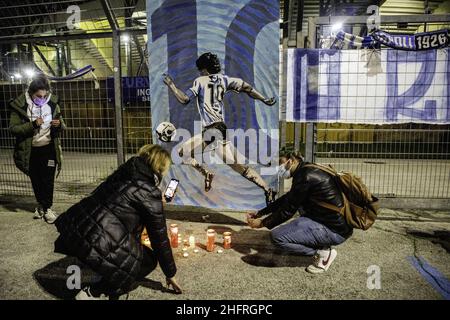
left=164, top=52, right=276, bottom=203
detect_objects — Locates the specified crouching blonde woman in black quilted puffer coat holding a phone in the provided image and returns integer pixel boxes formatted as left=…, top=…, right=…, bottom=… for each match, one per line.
left=55, top=145, right=181, bottom=299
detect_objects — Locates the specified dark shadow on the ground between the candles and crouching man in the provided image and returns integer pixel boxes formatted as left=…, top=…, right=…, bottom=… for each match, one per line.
left=208, top=225, right=312, bottom=268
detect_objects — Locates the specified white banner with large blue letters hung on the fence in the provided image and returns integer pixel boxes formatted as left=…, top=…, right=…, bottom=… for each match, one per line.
left=286, top=49, right=450, bottom=124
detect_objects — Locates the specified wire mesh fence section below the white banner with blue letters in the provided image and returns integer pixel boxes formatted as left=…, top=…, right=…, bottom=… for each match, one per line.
left=316, top=124, right=450, bottom=199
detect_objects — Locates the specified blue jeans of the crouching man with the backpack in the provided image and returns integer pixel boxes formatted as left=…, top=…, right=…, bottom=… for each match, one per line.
left=271, top=217, right=346, bottom=256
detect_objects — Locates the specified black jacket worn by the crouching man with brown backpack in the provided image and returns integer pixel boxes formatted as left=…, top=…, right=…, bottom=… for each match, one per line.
left=258, top=162, right=353, bottom=238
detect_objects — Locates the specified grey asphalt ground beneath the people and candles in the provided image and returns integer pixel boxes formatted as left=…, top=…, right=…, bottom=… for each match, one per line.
left=0, top=197, right=450, bottom=300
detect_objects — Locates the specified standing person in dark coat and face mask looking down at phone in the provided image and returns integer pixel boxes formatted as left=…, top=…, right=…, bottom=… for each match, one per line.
left=9, top=75, right=65, bottom=224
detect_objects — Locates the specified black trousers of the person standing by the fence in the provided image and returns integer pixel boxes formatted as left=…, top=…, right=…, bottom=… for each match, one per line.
left=30, top=143, right=56, bottom=210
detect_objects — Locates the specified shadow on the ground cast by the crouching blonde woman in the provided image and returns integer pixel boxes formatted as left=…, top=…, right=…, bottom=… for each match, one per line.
left=33, top=256, right=168, bottom=300
